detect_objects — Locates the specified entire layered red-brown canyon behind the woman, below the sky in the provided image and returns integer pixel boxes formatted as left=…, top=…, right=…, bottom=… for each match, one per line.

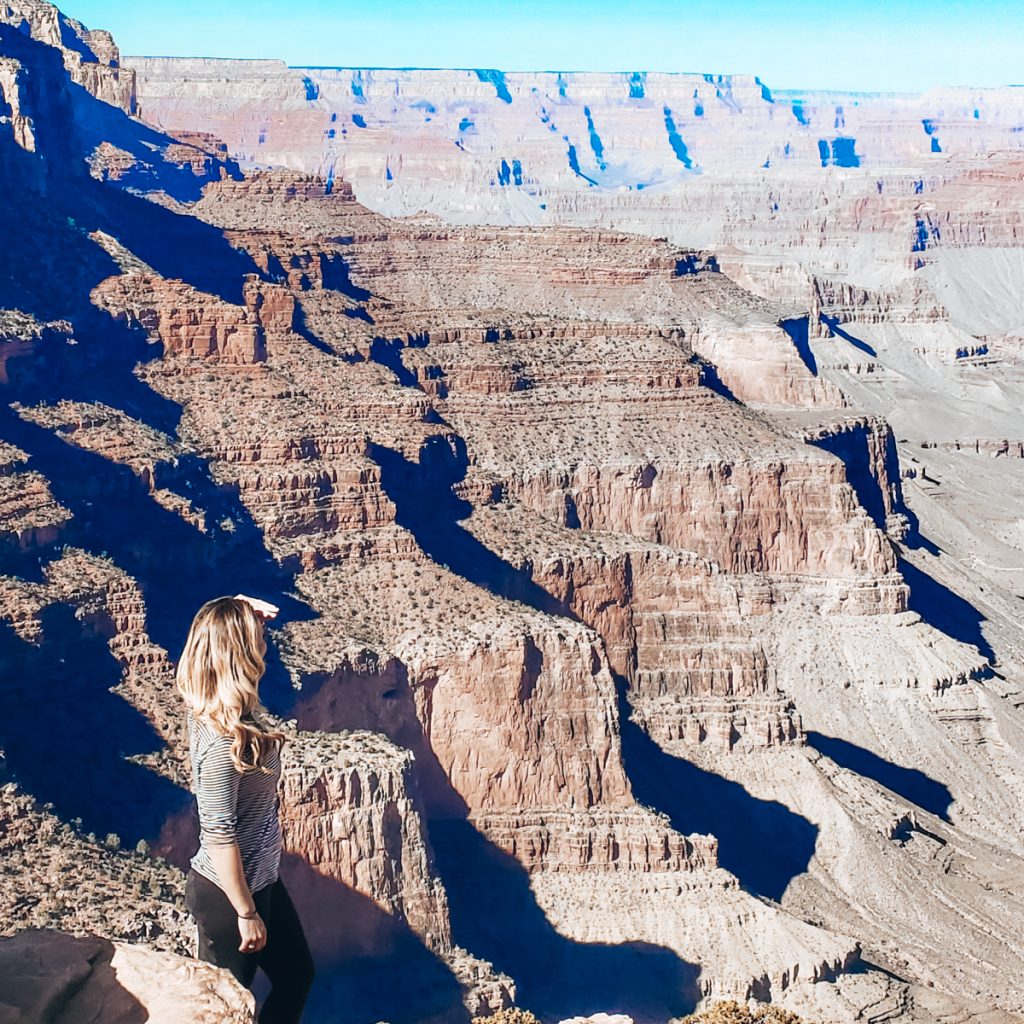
left=0, top=6, right=1024, bottom=1024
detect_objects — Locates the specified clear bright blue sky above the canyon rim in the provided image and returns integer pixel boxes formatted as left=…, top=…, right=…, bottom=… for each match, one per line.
left=70, top=0, right=1024, bottom=91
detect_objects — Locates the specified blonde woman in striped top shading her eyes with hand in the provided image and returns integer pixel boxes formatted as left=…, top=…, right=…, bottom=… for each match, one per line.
left=177, top=594, right=313, bottom=1024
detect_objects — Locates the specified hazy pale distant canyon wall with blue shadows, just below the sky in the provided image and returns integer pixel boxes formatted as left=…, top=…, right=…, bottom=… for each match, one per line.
left=126, top=57, right=1024, bottom=205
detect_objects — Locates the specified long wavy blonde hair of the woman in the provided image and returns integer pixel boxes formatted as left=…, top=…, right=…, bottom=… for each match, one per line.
left=176, top=597, right=285, bottom=772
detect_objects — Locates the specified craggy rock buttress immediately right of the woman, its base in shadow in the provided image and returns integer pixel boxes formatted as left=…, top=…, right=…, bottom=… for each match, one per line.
left=282, top=731, right=515, bottom=1015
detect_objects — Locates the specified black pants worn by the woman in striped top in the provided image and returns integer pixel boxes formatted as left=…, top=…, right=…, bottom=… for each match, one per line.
left=185, top=869, right=313, bottom=1024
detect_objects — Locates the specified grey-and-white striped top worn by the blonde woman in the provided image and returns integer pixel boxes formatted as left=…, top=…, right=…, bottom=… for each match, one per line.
left=188, top=708, right=281, bottom=892
